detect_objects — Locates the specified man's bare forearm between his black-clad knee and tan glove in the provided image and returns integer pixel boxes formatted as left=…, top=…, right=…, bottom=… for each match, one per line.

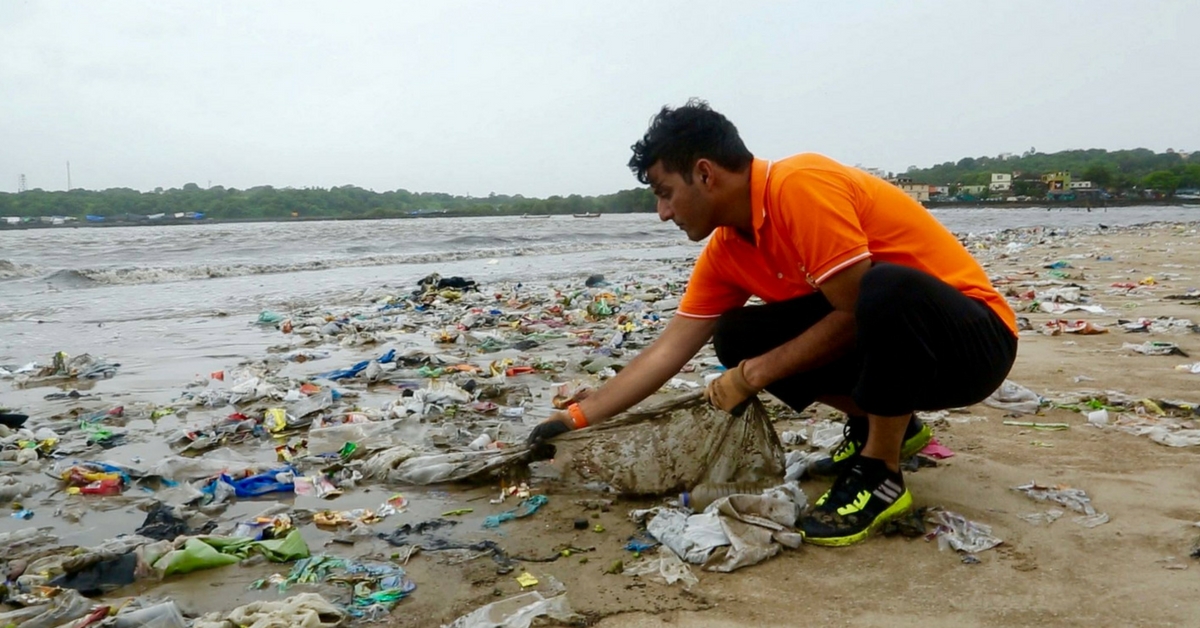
left=743, top=310, right=858, bottom=389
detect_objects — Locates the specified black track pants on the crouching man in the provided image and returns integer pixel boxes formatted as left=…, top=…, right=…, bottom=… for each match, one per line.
left=713, top=264, right=1016, bottom=417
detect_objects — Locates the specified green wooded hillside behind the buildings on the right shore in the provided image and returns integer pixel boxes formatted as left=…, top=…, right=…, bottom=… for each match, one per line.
left=905, top=149, right=1200, bottom=196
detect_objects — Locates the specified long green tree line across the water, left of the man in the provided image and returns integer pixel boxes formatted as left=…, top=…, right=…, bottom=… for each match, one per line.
left=0, top=184, right=655, bottom=220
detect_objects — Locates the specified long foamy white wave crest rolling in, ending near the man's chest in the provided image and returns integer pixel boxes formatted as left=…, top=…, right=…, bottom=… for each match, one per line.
left=32, top=239, right=682, bottom=289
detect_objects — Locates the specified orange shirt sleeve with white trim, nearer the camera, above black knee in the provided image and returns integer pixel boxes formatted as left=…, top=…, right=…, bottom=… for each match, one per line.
left=780, top=168, right=871, bottom=286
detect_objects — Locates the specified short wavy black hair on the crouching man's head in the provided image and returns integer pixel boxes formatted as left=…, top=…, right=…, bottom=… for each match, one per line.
left=629, top=98, right=754, bottom=184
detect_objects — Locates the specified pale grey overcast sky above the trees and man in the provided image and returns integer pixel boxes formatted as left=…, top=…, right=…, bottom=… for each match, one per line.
left=0, top=0, right=1200, bottom=197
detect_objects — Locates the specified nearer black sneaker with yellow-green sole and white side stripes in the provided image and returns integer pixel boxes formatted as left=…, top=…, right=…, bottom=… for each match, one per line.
left=798, top=456, right=912, bottom=548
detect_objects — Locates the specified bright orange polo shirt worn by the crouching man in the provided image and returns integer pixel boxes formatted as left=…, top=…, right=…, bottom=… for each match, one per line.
left=678, top=154, right=1016, bottom=335
